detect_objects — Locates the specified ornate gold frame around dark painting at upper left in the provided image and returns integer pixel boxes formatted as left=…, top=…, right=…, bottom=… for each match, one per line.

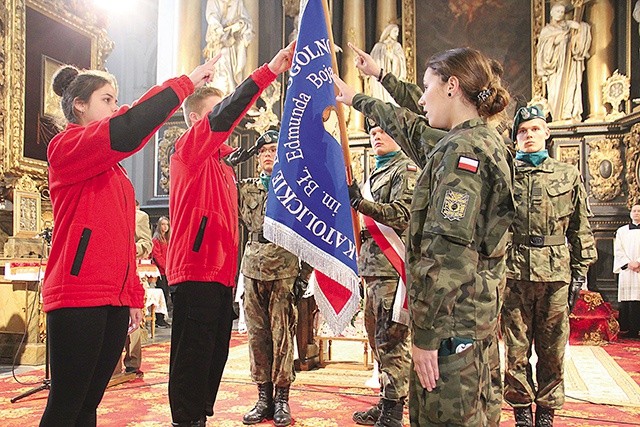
left=0, top=0, right=113, bottom=180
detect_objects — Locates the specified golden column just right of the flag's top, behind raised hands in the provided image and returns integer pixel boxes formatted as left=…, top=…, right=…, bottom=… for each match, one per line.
left=342, top=0, right=364, bottom=134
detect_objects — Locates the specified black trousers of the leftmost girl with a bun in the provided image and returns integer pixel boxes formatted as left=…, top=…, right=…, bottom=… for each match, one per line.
left=40, top=306, right=129, bottom=427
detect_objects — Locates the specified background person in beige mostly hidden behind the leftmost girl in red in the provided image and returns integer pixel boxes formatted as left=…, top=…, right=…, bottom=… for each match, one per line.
left=124, top=200, right=153, bottom=376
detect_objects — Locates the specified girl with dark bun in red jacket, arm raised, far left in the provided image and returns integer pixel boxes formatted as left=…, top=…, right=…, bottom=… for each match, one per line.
left=40, top=57, right=217, bottom=426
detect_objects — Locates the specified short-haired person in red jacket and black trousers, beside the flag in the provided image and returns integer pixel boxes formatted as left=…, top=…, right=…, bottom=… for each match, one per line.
left=167, top=43, right=294, bottom=427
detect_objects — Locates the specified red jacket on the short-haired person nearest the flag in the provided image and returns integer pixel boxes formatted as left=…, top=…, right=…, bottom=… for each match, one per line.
left=167, top=64, right=276, bottom=286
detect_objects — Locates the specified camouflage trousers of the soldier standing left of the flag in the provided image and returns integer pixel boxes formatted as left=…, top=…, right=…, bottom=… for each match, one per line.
left=243, top=277, right=298, bottom=387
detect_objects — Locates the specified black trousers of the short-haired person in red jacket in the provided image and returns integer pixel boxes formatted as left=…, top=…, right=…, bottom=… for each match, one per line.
left=169, top=282, right=233, bottom=423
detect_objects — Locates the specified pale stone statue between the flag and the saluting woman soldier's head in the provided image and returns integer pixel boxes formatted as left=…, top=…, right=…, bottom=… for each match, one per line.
left=369, top=24, right=407, bottom=104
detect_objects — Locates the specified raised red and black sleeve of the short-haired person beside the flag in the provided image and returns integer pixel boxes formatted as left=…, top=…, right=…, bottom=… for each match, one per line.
left=174, top=64, right=277, bottom=166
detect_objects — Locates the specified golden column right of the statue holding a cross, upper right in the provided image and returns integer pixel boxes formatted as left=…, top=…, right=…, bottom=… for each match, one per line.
left=585, top=0, right=615, bottom=121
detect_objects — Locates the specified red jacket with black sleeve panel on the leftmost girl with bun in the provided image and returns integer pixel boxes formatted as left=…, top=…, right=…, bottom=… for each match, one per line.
left=42, top=76, right=193, bottom=311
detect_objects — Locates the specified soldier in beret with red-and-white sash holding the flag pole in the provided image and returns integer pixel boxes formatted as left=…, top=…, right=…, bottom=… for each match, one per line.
left=349, top=117, right=419, bottom=427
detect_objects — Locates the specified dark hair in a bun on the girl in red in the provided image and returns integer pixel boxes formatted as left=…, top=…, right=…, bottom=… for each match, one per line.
left=51, top=65, right=118, bottom=123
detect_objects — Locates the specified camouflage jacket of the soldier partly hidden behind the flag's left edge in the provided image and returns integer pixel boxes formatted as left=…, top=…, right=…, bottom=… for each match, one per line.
left=238, top=178, right=300, bottom=280
